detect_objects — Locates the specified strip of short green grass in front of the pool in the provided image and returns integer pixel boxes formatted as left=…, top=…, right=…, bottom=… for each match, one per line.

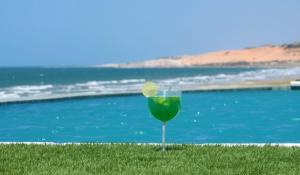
left=0, top=144, right=300, bottom=175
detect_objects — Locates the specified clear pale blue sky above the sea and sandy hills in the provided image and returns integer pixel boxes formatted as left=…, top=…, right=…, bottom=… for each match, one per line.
left=0, top=0, right=300, bottom=66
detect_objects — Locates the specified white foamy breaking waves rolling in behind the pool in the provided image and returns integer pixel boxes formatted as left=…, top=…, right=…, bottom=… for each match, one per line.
left=0, top=68, right=300, bottom=102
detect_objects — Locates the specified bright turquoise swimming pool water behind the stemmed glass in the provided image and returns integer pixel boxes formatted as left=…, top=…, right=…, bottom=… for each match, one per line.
left=0, top=90, right=300, bottom=143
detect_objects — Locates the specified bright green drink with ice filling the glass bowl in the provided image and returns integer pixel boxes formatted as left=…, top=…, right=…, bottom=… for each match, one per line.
left=148, top=96, right=180, bottom=122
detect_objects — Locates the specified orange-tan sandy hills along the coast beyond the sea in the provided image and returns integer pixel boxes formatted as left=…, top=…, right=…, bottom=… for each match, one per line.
left=100, top=43, right=300, bottom=68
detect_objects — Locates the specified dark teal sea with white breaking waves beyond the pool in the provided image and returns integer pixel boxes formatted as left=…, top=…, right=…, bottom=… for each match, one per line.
left=0, top=68, right=300, bottom=103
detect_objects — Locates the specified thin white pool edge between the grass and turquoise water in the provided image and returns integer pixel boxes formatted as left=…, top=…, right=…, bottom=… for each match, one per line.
left=0, top=142, right=300, bottom=147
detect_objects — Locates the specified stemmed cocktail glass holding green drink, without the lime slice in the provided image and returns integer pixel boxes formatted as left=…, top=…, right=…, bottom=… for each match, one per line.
left=148, top=90, right=181, bottom=151
